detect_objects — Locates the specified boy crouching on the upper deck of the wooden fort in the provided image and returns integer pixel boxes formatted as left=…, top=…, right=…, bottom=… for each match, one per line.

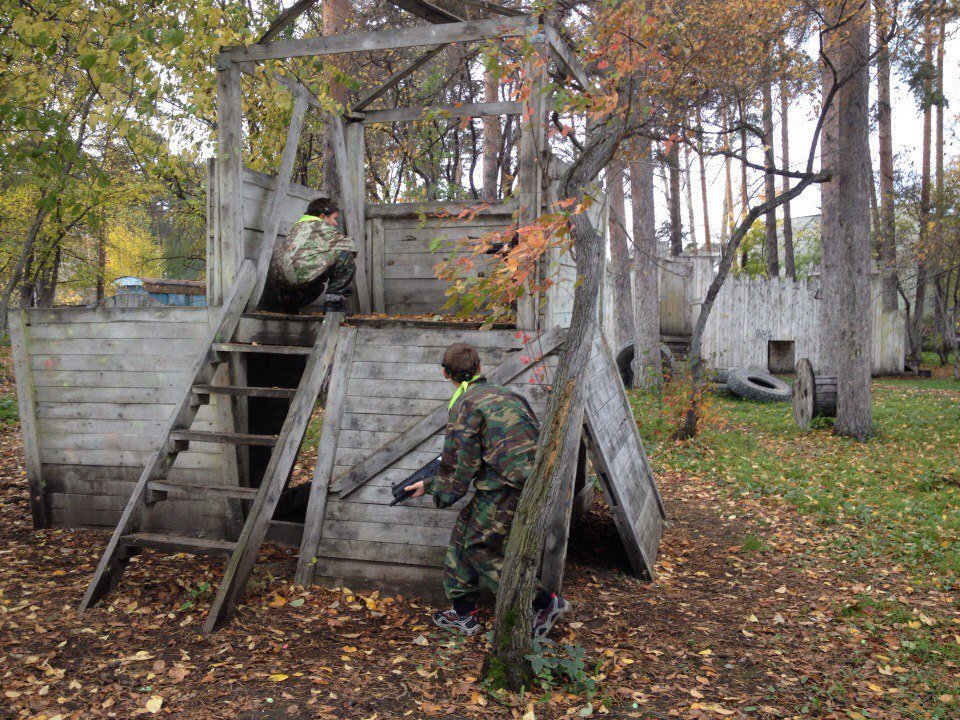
left=262, top=198, right=357, bottom=312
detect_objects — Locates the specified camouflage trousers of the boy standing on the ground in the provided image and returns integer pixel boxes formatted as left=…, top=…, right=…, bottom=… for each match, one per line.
left=443, top=487, right=520, bottom=600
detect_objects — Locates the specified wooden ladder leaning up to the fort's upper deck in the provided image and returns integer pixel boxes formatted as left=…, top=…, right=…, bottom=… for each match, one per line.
left=80, top=260, right=344, bottom=633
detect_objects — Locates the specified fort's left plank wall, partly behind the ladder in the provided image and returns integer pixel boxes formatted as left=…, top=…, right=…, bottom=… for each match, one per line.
left=17, top=307, right=228, bottom=535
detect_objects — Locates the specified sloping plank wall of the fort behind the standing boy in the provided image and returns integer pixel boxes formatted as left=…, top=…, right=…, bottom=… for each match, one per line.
left=316, top=327, right=555, bottom=592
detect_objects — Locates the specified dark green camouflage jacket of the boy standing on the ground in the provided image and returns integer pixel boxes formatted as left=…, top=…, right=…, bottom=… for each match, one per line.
left=425, top=376, right=540, bottom=507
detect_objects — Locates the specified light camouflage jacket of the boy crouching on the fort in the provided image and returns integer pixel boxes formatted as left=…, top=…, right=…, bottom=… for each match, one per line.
left=271, top=215, right=357, bottom=287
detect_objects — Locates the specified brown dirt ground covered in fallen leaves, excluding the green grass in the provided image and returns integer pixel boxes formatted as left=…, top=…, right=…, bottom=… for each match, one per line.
left=0, top=410, right=956, bottom=720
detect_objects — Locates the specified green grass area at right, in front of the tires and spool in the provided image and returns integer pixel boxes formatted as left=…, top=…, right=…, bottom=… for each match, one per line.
left=631, top=378, right=960, bottom=719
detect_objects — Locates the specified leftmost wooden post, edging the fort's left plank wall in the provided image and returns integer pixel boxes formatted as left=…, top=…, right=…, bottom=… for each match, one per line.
left=7, top=310, right=50, bottom=528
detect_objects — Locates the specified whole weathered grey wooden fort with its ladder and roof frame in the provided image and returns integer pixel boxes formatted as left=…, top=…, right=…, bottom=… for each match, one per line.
left=10, top=0, right=664, bottom=631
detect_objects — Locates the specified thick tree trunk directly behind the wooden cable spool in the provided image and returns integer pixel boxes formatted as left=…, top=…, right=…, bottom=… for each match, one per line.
left=822, top=0, right=873, bottom=440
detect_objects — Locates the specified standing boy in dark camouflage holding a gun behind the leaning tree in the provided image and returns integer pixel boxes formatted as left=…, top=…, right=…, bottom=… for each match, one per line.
left=410, top=343, right=570, bottom=637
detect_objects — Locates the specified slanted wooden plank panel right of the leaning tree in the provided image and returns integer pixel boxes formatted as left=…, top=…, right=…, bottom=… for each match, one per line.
left=584, top=336, right=665, bottom=579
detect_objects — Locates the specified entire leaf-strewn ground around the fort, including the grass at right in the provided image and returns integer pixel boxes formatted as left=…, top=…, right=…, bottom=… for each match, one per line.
left=0, top=358, right=960, bottom=720
